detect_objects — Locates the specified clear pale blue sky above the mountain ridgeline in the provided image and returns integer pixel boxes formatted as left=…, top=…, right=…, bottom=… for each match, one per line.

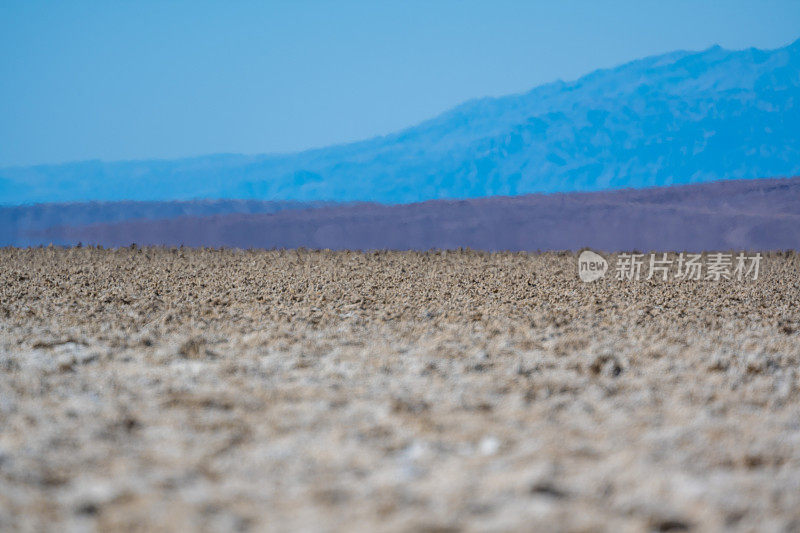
left=0, top=0, right=800, bottom=166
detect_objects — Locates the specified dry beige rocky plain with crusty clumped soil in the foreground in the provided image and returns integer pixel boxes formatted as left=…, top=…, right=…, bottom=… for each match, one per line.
left=0, top=248, right=800, bottom=531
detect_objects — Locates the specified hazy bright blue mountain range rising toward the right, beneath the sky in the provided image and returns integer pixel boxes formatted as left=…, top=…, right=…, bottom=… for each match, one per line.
left=0, top=41, right=800, bottom=205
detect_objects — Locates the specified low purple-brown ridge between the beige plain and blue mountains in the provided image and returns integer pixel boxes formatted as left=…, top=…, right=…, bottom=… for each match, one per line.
left=10, top=178, right=800, bottom=251
